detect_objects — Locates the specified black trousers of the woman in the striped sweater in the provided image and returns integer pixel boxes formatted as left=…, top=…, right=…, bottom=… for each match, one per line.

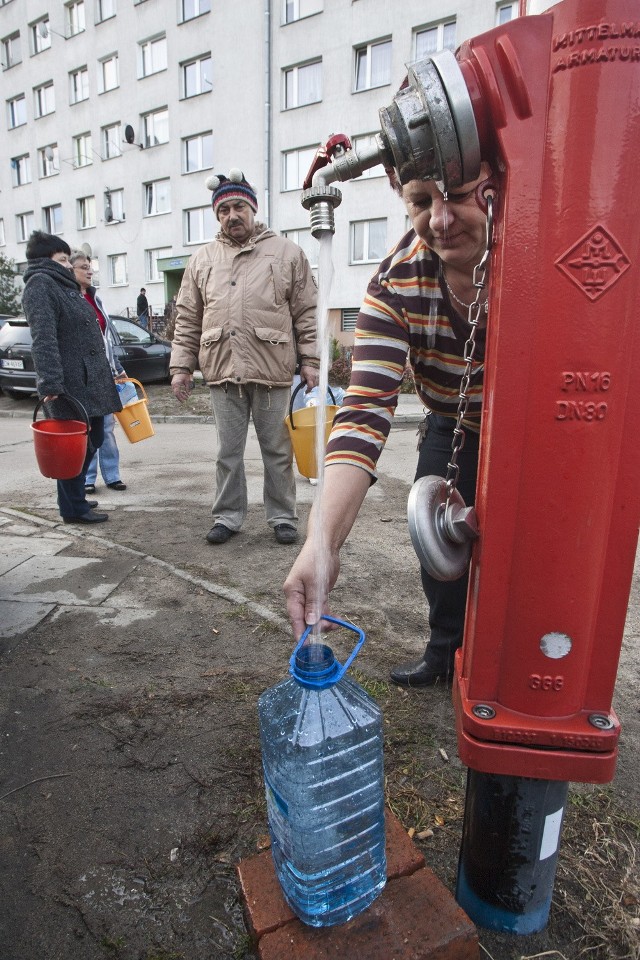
left=415, top=413, right=480, bottom=672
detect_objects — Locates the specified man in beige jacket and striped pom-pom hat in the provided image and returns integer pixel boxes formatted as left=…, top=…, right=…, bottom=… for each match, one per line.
left=171, top=170, right=319, bottom=544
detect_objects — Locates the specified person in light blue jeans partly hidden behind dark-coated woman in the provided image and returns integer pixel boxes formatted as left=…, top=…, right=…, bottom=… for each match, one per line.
left=71, top=250, right=127, bottom=493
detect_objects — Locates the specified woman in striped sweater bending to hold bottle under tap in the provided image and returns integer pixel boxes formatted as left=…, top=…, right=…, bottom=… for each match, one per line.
left=284, top=164, right=490, bottom=687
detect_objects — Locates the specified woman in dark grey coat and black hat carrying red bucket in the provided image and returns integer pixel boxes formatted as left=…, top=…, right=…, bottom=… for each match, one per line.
left=22, top=230, right=122, bottom=523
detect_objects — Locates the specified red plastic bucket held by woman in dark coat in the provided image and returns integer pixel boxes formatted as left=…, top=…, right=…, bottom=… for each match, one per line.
left=31, top=395, right=89, bottom=480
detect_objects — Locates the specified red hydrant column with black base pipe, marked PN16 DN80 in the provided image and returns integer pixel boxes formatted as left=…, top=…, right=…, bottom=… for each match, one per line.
left=454, top=0, right=640, bottom=933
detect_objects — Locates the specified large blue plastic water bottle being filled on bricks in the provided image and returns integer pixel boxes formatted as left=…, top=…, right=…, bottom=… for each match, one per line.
left=258, top=616, right=387, bottom=927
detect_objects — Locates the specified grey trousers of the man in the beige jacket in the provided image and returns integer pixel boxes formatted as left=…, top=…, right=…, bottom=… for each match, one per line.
left=211, top=383, right=298, bottom=530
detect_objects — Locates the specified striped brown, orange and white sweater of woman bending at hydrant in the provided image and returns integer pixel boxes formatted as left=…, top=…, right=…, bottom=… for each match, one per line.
left=325, top=230, right=485, bottom=478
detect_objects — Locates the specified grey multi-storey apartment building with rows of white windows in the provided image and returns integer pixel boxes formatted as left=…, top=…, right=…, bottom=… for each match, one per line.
left=0, top=0, right=519, bottom=328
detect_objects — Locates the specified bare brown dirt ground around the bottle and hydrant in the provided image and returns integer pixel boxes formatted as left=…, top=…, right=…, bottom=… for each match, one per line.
left=0, top=388, right=640, bottom=960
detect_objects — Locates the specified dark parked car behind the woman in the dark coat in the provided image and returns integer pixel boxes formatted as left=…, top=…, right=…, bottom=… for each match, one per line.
left=0, top=314, right=171, bottom=399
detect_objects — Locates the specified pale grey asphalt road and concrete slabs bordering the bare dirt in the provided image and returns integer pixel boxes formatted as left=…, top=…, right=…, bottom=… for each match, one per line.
left=0, top=396, right=423, bottom=640
